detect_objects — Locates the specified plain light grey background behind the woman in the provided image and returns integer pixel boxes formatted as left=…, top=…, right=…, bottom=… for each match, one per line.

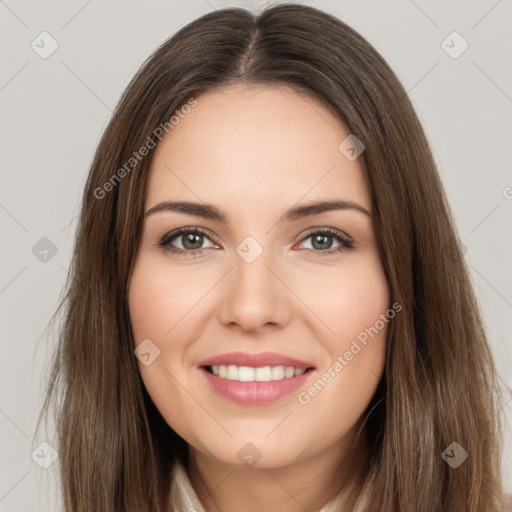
left=0, top=0, right=512, bottom=512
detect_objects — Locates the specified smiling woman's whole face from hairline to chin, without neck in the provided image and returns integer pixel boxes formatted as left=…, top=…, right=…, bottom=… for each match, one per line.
left=129, top=85, right=389, bottom=467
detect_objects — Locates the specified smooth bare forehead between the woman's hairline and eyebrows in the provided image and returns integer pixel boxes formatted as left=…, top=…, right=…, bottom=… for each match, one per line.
left=146, top=85, right=371, bottom=216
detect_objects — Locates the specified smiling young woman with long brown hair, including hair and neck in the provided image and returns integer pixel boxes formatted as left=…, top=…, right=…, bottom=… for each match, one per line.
left=35, top=5, right=505, bottom=512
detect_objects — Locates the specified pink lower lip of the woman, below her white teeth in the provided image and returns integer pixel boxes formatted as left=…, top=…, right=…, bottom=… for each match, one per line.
left=201, top=368, right=314, bottom=405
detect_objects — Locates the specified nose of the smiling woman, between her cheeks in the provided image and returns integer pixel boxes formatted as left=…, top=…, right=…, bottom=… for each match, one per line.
left=219, top=244, right=293, bottom=331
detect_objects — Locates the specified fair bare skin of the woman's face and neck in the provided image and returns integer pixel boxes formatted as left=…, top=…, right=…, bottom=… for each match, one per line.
left=129, top=85, right=390, bottom=512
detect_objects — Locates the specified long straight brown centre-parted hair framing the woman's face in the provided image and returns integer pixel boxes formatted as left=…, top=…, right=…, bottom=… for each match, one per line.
left=38, top=4, right=503, bottom=512
